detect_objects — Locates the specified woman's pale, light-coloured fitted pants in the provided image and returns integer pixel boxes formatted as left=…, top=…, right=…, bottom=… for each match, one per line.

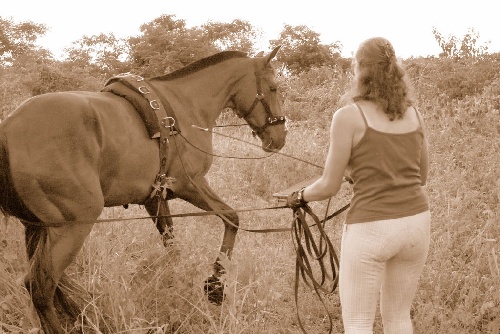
left=339, top=211, right=431, bottom=334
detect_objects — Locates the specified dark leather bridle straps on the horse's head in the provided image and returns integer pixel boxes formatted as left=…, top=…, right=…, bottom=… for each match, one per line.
left=231, top=61, right=286, bottom=136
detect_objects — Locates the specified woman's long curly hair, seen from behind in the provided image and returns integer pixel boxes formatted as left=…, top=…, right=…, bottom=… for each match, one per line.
left=342, top=37, right=414, bottom=121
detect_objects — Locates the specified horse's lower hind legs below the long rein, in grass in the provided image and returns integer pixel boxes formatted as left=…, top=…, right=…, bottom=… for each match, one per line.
left=25, top=220, right=92, bottom=334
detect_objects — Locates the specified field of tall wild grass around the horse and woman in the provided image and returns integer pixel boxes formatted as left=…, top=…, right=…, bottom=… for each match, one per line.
left=0, top=58, right=500, bottom=334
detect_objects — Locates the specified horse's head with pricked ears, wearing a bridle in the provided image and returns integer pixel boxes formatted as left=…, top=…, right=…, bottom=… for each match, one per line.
left=231, top=46, right=287, bottom=152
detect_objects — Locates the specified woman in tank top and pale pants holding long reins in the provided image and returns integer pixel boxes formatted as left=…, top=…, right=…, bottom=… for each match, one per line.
left=287, top=37, right=430, bottom=334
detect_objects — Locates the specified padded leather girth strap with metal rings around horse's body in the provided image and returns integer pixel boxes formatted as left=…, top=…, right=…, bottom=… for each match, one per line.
left=101, top=73, right=181, bottom=200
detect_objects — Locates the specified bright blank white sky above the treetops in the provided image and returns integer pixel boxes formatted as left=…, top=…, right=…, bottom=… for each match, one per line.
left=0, top=0, right=500, bottom=58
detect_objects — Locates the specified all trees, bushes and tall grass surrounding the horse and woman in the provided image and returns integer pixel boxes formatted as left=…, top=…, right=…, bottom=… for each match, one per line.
left=0, top=15, right=500, bottom=334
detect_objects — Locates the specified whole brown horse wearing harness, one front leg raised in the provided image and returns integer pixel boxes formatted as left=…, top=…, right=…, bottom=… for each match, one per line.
left=0, top=47, right=287, bottom=334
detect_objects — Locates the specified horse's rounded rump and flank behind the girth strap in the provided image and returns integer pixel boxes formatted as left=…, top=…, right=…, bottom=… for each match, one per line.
left=0, top=92, right=155, bottom=221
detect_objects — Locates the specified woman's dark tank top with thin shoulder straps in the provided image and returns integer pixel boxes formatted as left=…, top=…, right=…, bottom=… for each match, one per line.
left=346, top=104, right=429, bottom=224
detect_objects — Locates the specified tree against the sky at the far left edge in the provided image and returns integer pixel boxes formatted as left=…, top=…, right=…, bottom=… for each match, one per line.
left=0, top=17, right=50, bottom=66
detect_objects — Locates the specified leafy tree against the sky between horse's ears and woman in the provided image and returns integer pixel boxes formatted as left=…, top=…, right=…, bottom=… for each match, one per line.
left=270, top=24, right=342, bottom=73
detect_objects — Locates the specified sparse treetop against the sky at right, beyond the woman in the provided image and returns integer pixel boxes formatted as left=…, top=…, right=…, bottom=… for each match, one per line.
left=432, top=27, right=490, bottom=59
